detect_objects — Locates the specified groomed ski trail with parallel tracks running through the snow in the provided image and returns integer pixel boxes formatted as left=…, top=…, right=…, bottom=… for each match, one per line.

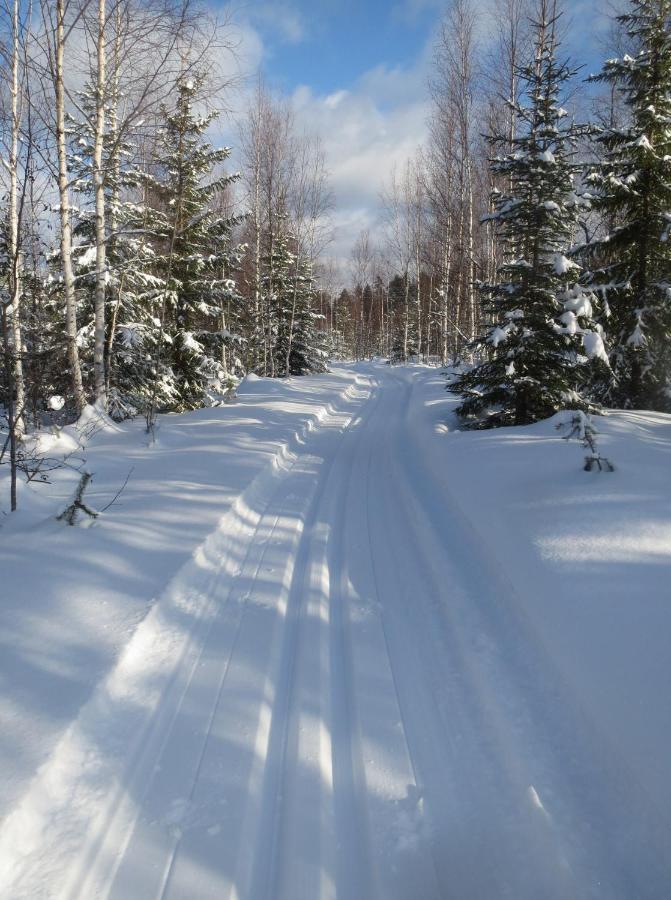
left=0, top=365, right=671, bottom=900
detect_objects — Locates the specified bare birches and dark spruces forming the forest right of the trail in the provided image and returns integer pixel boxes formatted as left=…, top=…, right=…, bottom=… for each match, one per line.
left=342, top=0, right=671, bottom=427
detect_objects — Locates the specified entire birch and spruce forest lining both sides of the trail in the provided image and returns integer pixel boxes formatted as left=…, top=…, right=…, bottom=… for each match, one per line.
left=0, top=0, right=671, bottom=506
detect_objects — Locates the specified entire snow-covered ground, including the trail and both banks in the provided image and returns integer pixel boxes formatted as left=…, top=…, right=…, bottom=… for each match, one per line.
left=0, top=363, right=671, bottom=900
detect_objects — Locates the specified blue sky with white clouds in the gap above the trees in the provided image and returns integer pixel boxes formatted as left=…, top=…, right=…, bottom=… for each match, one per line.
left=220, top=0, right=608, bottom=268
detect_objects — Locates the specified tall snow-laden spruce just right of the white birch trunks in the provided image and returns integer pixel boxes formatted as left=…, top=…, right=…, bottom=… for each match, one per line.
left=151, top=77, right=240, bottom=410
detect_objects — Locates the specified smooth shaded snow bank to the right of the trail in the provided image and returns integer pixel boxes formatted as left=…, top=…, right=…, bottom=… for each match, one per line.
left=412, top=374, right=671, bottom=820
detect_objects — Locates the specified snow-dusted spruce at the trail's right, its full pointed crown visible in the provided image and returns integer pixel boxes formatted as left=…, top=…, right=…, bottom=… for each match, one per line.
left=448, top=0, right=603, bottom=428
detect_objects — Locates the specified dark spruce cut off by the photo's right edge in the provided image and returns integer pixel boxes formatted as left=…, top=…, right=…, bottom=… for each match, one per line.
left=581, top=0, right=671, bottom=411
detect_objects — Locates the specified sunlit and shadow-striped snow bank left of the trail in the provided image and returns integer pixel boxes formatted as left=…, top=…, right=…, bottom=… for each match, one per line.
left=0, top=367, right=368, bottom=844
